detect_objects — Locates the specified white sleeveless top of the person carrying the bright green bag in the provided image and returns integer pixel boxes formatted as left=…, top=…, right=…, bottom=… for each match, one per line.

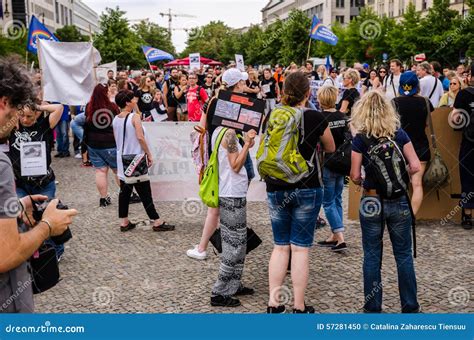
left=212, top=127, right=248, bottom=198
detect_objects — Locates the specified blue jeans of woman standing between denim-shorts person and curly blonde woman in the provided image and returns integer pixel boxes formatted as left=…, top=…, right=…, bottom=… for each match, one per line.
left=323, top=168, right=344, bottom=233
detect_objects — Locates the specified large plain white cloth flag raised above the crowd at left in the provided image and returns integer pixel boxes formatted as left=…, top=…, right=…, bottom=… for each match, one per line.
left=38, top=39, right=101, bottom=105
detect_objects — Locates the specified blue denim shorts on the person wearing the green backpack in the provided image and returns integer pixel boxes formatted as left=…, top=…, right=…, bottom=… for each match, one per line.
left=267, top=188, right=323, bottom=248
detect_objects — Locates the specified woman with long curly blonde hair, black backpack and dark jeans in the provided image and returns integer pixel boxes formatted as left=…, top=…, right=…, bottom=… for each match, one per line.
left=351, top=91, right=420, bottom=313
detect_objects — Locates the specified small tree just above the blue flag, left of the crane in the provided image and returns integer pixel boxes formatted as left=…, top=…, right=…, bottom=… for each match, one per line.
left=133, top=20, right=176, bottom=55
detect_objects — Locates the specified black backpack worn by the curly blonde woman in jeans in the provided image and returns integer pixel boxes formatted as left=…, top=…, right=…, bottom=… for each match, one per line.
left=363, top=136, right=410, bottom=199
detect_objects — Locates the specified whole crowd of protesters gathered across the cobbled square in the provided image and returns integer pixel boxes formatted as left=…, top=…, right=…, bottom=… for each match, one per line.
left=0, top=52, right=474, bottom=313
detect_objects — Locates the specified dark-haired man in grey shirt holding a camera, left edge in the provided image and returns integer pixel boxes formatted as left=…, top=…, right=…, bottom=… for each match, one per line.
left=0, top=59, right=77, bottom=313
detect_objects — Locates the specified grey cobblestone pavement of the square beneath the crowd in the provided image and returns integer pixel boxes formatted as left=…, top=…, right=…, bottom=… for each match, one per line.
left=35, top=159, right=474, bottom=313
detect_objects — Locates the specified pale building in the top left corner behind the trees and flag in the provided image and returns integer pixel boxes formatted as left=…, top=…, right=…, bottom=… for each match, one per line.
left=0, top=0, right=99, bottom=34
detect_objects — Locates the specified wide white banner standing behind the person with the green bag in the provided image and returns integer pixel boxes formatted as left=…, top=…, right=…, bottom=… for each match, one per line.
left=143, top=122, right=267, bottom=202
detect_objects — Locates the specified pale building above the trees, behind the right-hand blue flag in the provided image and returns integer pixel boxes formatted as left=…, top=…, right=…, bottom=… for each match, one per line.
left=262, top=0, right=360, bottom=27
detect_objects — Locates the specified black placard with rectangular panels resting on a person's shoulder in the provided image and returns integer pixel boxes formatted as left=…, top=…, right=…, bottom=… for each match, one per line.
left=211, top=91, right=265, bottom=131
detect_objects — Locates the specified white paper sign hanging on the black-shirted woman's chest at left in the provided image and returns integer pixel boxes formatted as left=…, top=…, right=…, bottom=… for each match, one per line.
left=20, top=142, right=48, bottom=177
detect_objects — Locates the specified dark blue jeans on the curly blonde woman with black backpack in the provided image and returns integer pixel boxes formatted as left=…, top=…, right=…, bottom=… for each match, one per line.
left=359, top=196, right=420, bottom=313
